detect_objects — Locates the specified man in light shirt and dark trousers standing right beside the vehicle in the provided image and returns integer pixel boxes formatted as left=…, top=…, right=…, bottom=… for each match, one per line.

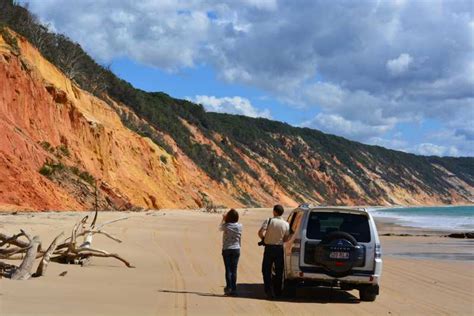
left=258, top=205, right=290, bottom=299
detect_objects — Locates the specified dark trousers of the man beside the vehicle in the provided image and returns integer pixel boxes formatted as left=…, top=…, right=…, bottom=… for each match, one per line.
left=262, top=245, right=283, bottom=296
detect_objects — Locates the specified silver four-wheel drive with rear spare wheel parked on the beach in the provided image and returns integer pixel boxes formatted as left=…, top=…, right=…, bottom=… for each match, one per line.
left=284, top=205, right=382, bottom=301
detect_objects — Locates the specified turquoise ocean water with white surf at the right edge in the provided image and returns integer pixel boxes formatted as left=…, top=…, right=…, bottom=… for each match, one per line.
left=371, top=205, right=474, bottom=231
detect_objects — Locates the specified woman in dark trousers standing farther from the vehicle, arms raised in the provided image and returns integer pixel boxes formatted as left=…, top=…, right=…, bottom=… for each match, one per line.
left=220, top=209, right=242, bottom=296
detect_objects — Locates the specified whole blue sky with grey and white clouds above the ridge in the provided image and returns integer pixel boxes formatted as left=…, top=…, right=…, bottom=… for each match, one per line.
left=24, top=0, right=474, bottom=156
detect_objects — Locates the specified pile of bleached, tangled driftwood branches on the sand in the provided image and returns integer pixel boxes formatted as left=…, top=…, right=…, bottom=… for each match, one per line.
left=0, top=211, right=133, bottom=280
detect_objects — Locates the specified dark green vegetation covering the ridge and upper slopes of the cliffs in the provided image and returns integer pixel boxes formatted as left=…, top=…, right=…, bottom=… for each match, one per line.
left=0, top=0, right=474, bottom=205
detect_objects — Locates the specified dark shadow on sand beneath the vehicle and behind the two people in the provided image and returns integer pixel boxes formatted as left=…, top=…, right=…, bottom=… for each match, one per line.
left=158, top=283, right=360, bottom=304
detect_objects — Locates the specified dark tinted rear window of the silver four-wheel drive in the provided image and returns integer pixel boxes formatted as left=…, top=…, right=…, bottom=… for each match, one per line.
left=306, top=212, right=370, bottom=242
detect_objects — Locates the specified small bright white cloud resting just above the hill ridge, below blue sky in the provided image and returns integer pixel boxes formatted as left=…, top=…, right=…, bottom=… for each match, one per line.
left=188, top=95, right=271, bottom=118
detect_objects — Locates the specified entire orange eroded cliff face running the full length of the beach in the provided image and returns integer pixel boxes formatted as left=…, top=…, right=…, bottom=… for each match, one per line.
left=0, top=33, right=474, bottom=210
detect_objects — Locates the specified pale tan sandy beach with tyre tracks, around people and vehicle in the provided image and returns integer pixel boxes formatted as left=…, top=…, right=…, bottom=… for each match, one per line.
left=0, top=209, right=474, bottom=315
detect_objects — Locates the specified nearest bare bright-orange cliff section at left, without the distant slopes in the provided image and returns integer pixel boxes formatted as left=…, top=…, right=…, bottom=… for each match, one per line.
left=0, top=30, right=274, bottom=210
